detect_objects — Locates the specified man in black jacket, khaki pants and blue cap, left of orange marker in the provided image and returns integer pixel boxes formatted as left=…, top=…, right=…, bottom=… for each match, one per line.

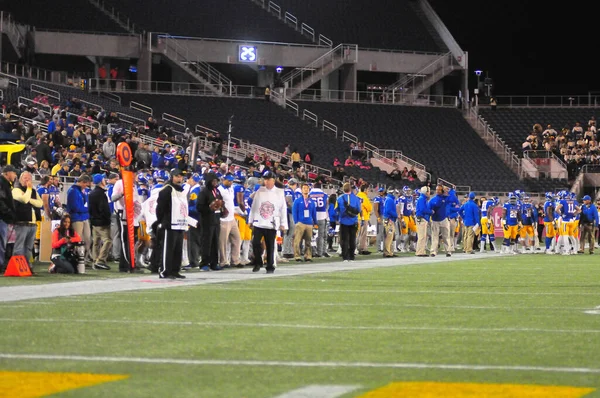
left=88, top=174, right=112, bottom=270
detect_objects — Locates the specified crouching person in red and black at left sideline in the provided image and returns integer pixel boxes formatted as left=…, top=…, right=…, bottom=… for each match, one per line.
left=48, top=214, right=83, bottom=274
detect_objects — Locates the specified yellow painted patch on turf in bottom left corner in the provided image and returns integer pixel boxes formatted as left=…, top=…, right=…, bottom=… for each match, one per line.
left=0, top=371, right=129, bottom=398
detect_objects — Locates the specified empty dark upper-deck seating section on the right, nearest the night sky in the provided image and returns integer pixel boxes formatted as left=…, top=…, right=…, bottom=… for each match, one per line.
left=276, top=0, right=447, bottom=52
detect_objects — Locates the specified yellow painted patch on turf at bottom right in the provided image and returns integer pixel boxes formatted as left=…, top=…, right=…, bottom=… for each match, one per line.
left=360, top=382, right=596, bottom=398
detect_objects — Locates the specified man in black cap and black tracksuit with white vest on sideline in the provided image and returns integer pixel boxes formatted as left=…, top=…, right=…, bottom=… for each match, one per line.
left=156, top=169, right=188, bottom=279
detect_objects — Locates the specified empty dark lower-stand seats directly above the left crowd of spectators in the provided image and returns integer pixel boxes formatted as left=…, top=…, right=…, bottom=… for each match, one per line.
left=115, top=94, right=398, bottom=185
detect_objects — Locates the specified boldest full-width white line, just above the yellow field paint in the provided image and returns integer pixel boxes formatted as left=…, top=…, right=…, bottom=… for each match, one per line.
left=0, top=353, right=600, bottom=374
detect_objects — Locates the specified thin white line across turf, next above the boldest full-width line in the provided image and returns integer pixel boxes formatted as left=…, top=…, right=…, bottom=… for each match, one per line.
left=0, top=318, right=600, bottom=334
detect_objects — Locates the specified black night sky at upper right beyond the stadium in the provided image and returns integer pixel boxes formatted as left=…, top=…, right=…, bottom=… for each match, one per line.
left=429, top=0, right=600, bottom=95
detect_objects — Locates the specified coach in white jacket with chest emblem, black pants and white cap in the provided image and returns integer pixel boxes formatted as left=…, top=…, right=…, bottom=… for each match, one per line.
left=248, top=171, right=288, bottom=274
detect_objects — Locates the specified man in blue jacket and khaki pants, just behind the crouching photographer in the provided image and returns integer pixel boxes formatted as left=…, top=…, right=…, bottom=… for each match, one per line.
left=67, top=174, right=93, bottom=263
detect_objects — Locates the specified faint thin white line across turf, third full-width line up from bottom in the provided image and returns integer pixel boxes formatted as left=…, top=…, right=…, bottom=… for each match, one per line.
left=47, top=297, right=589, bottom=311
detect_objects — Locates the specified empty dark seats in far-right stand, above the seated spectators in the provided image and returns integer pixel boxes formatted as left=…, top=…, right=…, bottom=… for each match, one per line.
left=479, top=107, right=596, bottom=156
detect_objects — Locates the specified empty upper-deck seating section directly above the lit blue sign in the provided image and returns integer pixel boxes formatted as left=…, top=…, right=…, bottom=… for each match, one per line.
left=99, top=0, right=312, bottom=44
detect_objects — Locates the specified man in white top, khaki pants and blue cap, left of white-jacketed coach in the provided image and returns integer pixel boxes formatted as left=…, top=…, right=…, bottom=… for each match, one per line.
left=217, top=173, right=242, bottom=268
